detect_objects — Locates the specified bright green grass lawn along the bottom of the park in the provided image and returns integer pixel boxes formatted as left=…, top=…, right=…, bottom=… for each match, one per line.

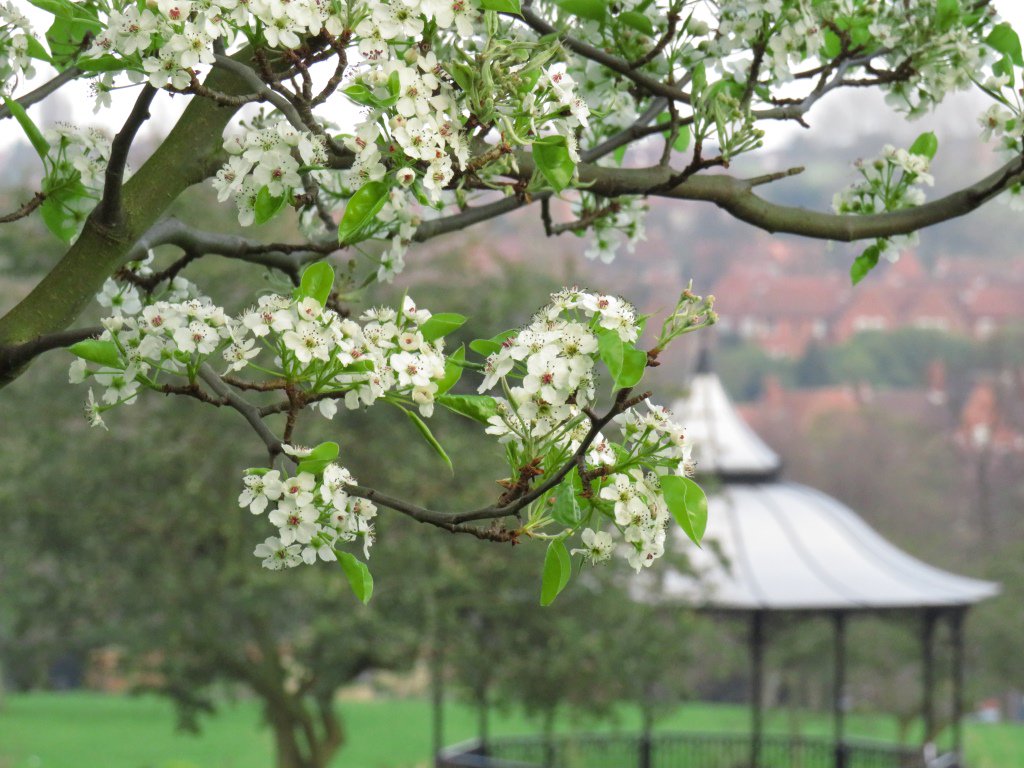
left=0, top=692, right=1024, bottom=768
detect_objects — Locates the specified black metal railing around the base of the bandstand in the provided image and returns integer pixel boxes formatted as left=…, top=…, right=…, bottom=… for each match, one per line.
left=437, top=733, right=927, bottom=768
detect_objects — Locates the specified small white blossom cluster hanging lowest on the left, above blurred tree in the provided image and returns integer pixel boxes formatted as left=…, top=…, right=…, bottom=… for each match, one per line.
left=239, top=456, right=377, bottom=570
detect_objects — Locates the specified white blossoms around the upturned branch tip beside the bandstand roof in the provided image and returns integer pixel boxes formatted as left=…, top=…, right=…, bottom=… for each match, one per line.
left=479, top=289, right=693, bottom=570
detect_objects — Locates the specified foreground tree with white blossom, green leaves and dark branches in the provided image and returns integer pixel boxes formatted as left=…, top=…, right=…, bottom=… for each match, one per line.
left=0, top=0, right=1024, bottom=603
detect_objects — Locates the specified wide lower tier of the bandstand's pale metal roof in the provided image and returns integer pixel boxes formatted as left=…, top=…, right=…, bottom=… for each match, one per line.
left=665, top=482, right=999, bottom=610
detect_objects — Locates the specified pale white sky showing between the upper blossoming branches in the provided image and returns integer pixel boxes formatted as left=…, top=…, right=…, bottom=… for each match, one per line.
left=6, top=0, right=1024, bottom=159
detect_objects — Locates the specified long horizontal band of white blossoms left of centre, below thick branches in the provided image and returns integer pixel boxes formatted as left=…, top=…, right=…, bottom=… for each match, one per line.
left=70, top=278, right=445, bottom=425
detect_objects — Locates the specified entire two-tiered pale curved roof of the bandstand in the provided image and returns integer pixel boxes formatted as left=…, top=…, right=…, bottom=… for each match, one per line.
left=664, top=371, right=999, bottom=611
